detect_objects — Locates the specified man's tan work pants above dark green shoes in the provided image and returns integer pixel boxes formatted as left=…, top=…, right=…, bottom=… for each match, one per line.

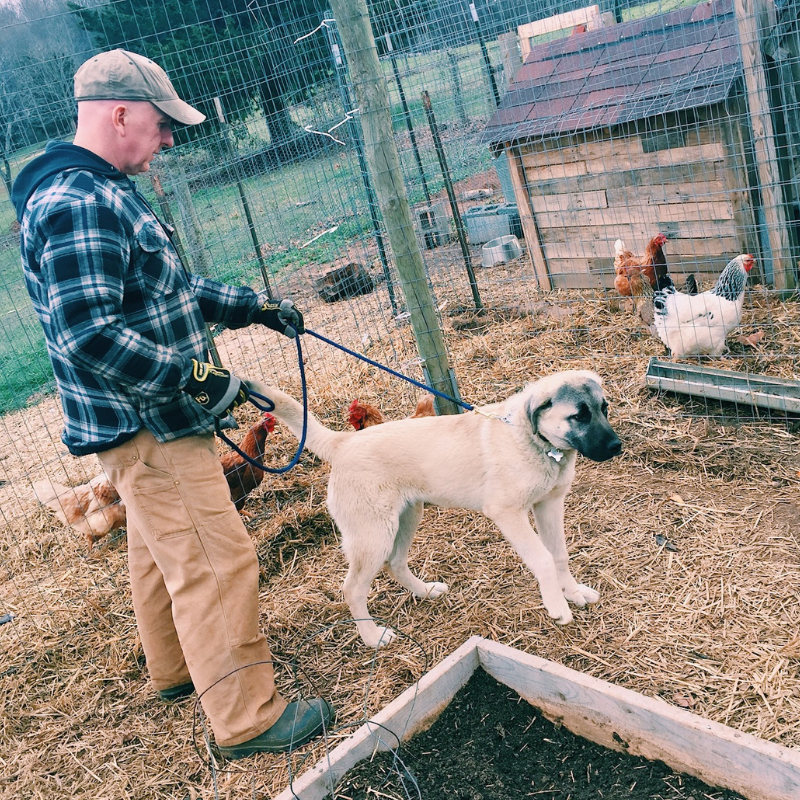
left=98, top=430, right=286, bottom=746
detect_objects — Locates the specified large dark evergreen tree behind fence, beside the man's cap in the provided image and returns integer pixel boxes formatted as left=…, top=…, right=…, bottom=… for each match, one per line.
left=70, top=0, right=330, bottom=156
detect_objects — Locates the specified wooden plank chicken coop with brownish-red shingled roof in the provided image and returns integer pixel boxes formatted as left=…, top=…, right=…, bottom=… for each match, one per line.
left=485, top=0, right=794, bottom=288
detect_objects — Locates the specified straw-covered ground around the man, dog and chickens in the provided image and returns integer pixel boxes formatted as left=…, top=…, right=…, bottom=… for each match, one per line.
left=0, top=249, right=800, bottom=800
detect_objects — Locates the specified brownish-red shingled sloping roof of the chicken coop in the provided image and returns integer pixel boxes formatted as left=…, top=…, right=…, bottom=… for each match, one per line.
left=482, top=0, right=742, bottom=143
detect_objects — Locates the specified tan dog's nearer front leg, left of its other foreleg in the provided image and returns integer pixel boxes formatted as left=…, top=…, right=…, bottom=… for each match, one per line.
left=484, top=508, right=572, bottom=625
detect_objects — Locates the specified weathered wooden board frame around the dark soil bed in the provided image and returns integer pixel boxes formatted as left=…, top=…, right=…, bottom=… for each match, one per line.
left=276, top=636, right=800, bottom=800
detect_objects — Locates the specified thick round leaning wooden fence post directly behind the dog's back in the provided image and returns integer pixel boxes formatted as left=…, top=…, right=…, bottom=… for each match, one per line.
left=331, top=0, right=460, bottom=414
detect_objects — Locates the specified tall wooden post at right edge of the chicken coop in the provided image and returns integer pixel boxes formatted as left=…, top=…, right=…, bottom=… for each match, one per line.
left=734, top=0, right=796, bottom=289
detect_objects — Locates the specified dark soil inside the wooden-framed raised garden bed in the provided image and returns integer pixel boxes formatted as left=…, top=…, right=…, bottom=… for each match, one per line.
left=337, top=669, right=742, bottom=800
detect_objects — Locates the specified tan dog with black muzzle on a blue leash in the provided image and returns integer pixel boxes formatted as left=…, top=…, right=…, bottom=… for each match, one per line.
left=248, top=370, right=622, bottom=647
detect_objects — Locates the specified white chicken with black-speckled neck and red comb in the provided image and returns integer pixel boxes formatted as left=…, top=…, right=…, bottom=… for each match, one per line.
left=653, top=254, right=755, bottom=356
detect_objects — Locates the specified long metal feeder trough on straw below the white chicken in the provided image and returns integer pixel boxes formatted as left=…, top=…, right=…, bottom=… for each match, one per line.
left=645, top=358, right=800, bottom=414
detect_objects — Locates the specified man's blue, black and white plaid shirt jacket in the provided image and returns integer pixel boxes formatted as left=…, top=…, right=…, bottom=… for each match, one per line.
left=22, top=170, right=265, bottom=455
